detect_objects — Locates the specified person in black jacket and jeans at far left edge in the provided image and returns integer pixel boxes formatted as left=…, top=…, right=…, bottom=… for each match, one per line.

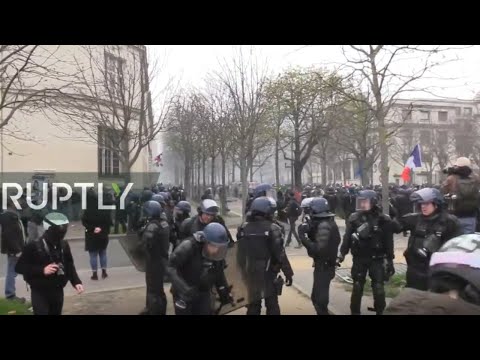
left=0, top=198, right=26, bottom=302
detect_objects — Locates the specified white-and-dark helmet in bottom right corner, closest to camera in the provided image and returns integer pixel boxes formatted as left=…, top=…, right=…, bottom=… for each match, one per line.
left=430, top=234, right=480, bottom=305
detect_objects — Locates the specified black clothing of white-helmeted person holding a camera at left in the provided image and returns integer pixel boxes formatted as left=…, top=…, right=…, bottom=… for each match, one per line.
left=15, top=235, right=82, bottom=315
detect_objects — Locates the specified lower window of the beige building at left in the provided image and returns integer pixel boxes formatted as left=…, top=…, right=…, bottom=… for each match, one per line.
left=98, top=127, right=121, bottom=176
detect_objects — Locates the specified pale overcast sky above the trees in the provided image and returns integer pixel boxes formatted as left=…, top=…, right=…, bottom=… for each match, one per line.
left=148, top=45, right=480, bottom=99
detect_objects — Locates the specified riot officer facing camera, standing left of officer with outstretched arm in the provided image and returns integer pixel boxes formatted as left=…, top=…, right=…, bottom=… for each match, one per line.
left=337, top=190, right=395, bottom=315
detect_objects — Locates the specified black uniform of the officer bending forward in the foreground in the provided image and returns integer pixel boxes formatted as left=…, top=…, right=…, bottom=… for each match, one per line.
left=168, top=237, right=228, bottom=315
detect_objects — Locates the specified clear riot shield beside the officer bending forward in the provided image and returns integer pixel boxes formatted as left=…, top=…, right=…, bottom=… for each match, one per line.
left=213, top=239, right=265, bottom=315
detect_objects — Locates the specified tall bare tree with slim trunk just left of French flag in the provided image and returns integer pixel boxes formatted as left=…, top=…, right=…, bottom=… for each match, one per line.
left=343, top=45, right=456, bottom=213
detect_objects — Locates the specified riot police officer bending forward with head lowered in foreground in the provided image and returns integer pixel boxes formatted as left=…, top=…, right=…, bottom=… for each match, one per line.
left=168, top=223, right=232, bottom=315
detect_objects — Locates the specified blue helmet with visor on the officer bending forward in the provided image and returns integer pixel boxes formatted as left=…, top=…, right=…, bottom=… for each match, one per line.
left=193, top=223, right=232, bottom=261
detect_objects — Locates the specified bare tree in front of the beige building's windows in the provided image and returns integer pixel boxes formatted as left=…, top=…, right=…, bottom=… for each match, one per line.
left=49, top=45, right=172, bottom=181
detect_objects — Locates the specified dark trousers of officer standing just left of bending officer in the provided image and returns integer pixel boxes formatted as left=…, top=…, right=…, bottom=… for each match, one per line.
left=145, top=259, right=167, bottom=315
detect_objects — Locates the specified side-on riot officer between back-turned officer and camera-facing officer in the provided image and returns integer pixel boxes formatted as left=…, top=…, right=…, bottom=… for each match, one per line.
left=298, top=197, right=340, bottom=315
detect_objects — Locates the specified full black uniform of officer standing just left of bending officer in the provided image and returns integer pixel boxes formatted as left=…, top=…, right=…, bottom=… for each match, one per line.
left=141, top=214, right=170, bottom=315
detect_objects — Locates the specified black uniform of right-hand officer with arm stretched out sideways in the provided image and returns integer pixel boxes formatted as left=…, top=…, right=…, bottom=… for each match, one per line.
left=393, top=210, right=463, bottom=291
